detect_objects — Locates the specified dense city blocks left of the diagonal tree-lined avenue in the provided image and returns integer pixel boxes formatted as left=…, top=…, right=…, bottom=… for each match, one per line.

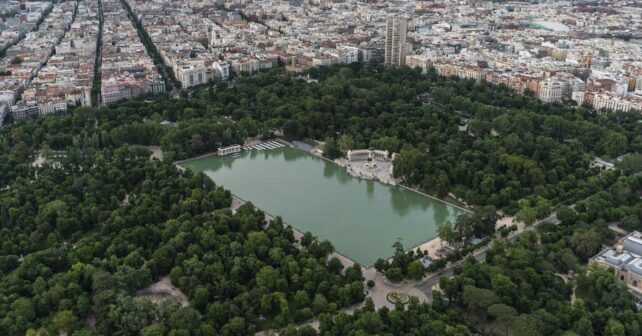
left=0, top=0, right=172, bottom=126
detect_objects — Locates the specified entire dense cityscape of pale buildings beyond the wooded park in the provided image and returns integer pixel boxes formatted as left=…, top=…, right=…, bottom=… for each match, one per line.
left=0, top=0, right=642, bottom=125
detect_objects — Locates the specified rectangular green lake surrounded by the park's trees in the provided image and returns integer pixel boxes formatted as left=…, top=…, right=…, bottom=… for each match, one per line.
left=181, top=147, right=465, bottom=266
